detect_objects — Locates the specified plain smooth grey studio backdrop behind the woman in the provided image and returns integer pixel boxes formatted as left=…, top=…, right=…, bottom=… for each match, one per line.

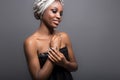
left=0, top=0, right=120, bottom=80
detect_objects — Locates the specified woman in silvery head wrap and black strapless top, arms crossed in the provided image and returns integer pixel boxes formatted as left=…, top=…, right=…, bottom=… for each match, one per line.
left=24, top=0, right=78, bottom=80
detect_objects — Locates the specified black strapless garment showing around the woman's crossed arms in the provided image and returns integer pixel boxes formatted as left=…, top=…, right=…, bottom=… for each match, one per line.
left=38, top=47, right=73, bottom=80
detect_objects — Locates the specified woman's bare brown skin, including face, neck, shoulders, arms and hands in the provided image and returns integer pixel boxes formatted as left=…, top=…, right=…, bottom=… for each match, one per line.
left=24, top=1, right=78, bottom=80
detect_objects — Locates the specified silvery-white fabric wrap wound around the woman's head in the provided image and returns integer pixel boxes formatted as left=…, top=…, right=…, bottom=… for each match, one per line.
left=33, top=0, right=63, bottom=19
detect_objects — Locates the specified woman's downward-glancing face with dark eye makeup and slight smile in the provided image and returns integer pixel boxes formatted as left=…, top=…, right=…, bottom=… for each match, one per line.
left=42, top=1, right=63, bottom=28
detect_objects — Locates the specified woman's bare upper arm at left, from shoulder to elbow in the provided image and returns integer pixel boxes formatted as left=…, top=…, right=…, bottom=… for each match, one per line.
left=24, top=39, right=40, bottom=77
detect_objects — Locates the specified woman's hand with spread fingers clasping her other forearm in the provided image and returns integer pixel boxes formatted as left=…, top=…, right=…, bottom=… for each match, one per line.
left=48, top=48, right=67, bottom=66
